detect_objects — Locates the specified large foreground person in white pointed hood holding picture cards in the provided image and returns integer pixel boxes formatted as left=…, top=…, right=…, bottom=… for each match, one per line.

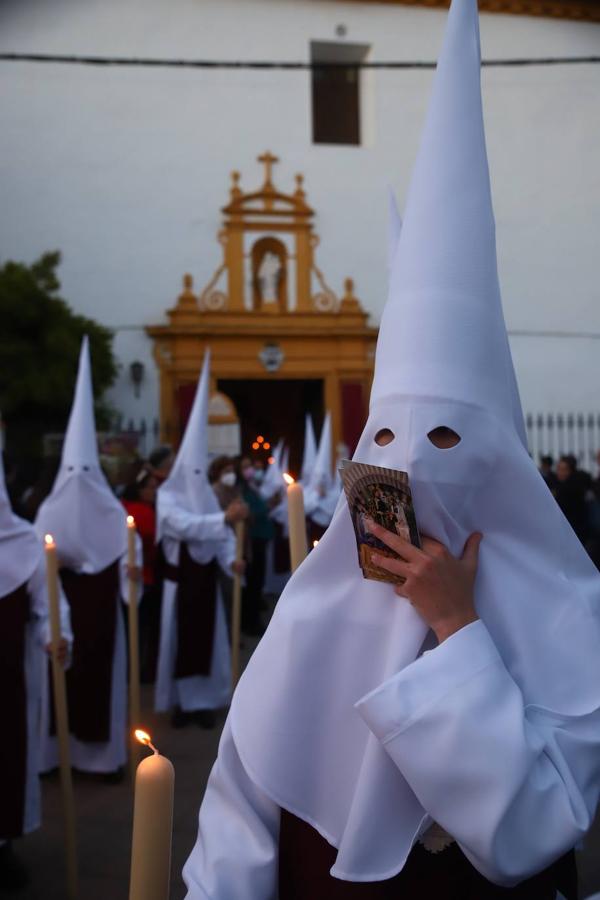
left=184, top=0, right=600, bottom=900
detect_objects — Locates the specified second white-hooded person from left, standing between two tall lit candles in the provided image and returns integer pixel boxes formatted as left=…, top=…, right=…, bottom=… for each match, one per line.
left=35, top=337, right=140, bottom=773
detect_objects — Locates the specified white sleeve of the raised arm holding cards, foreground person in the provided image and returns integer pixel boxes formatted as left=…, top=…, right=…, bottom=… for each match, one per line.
left=357, top=621, right=600, bottom=885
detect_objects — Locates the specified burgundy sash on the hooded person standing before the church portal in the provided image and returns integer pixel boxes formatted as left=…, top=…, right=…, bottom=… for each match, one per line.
left=172, top=544, right=217, bottom=678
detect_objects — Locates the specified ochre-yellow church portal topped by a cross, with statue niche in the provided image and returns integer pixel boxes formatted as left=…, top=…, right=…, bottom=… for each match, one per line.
left=147, top=152, right=377, bottom=470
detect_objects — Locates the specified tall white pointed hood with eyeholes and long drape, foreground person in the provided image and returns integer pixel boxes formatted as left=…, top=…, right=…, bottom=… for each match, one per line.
left=231, top=0, right=600, bottom=881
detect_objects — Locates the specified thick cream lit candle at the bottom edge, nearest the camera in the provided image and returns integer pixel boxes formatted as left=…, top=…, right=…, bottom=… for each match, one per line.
left=129, top=729, right=175, bottom=900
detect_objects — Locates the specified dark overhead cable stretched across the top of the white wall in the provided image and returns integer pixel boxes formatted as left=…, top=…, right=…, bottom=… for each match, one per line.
left=0, top=53, right=600, bottom=71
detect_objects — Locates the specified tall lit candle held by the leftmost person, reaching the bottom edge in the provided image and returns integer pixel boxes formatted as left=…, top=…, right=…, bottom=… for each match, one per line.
left=45, top=534, right=77, bottom=900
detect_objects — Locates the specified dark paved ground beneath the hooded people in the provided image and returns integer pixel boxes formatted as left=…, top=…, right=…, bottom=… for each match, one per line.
left=7, top=628, right=600, bottom=900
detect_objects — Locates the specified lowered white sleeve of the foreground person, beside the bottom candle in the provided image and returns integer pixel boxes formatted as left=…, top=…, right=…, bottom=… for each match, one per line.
left=183, top=721, right=280, bottom=900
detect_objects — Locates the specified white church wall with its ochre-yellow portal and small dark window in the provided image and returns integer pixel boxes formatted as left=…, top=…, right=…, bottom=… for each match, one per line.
left=0, top=0, right=600, bottom=464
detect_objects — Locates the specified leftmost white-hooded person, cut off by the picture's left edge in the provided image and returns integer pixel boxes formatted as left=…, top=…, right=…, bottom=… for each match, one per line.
left=0, top=456, right=72, bottom=889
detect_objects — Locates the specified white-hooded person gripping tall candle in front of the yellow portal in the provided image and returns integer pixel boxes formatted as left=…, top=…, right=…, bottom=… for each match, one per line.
left=155, top=353, right=248, bottom=727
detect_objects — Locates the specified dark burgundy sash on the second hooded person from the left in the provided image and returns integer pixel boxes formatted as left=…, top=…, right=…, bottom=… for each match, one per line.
left=50, top=559, right=119, bottom=743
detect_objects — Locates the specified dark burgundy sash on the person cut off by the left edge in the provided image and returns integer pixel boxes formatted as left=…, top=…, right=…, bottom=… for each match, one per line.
left=0, top=584, right=29, bottom=840
